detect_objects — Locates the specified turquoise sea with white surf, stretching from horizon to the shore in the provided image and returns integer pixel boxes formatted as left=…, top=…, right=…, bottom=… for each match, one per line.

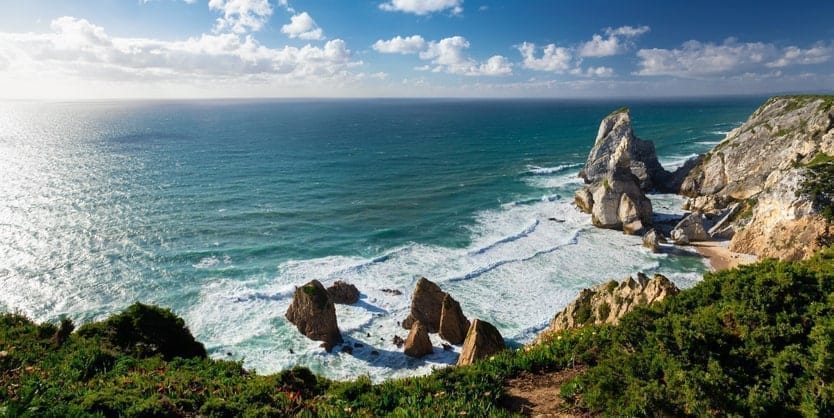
left=0, top=98, right=763, bottom=379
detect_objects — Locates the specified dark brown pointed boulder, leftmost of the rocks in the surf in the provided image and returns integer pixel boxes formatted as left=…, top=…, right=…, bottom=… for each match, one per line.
left=285, top=280, right=342, bottom=353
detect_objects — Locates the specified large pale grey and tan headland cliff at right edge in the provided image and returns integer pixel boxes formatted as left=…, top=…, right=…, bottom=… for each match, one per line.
left=680, top=96, right=834, bottom=259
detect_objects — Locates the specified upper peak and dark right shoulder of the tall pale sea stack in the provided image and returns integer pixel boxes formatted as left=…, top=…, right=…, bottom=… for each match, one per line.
left=579, top=109, right=669, bottom=191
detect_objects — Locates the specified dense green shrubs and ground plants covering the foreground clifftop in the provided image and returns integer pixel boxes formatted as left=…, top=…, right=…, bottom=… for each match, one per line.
left=0, top=249, right=834, bottom=417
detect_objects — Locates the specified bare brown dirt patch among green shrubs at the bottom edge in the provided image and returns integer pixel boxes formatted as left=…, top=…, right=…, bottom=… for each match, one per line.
left=503, top=367, right=589, bottom=418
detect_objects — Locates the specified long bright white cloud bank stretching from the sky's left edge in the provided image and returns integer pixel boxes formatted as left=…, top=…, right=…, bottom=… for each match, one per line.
left=0, top=17, right=361, bottom=83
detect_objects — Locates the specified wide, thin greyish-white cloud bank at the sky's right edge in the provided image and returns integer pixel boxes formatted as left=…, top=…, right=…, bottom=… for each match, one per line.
left=636, top=38, right=834, bottom=77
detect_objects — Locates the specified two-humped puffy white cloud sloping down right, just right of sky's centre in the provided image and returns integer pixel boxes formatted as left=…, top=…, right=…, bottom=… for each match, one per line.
left=420, top=36, right=512, bottom=76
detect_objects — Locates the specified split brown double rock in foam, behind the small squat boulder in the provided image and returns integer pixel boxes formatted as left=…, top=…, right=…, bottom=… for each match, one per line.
left=402, top=277, right=469, bottom=344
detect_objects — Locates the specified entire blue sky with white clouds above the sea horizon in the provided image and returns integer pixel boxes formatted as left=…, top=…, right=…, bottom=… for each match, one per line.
left=0, top=0, right=834, bottom=100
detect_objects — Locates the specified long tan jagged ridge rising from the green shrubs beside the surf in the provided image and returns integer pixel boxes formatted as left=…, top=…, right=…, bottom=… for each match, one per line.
left=537, top=273, right=679, bottom=342
